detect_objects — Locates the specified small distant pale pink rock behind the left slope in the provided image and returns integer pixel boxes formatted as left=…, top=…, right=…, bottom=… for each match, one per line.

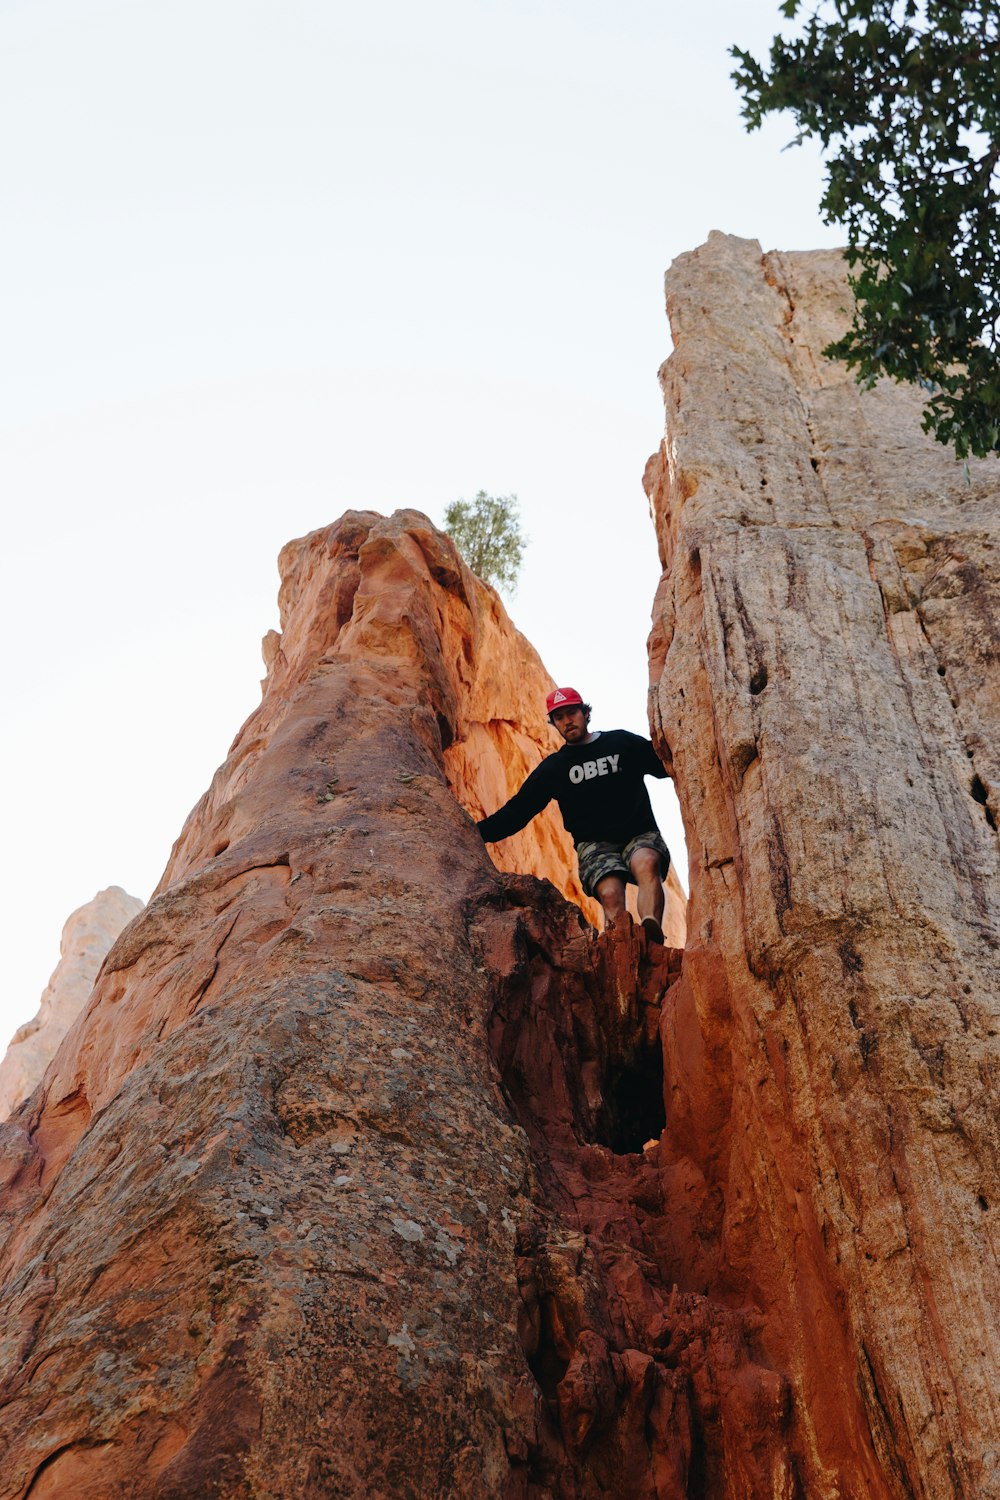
left=0, top=885, right=142, bottom=1119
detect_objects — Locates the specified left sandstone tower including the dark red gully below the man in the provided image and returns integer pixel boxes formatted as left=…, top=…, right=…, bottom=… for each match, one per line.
left=0, top=512, right=683, bottom=1500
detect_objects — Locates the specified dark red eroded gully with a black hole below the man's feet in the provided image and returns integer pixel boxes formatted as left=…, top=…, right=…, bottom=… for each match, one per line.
left=469, top=876, right=802, bottom=1500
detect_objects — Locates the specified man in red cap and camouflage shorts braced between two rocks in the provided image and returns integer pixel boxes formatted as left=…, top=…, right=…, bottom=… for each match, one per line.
left=478, top=687, right=670, bottom=942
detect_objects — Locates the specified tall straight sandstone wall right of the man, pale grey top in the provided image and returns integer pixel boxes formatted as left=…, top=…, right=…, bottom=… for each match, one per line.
left=646, top=234, right=1000, bottom=1500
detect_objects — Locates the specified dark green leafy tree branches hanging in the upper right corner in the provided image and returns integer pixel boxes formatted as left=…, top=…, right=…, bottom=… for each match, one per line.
left=732, top=0, right=1000, bottom=458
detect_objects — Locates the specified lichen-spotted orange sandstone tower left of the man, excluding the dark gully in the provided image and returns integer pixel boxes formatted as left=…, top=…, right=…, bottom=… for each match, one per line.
left=0, top=512, right=626, bottom=1500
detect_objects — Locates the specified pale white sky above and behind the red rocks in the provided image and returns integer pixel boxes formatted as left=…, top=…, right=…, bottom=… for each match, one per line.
left=0, top=0, right=843, bottom=1053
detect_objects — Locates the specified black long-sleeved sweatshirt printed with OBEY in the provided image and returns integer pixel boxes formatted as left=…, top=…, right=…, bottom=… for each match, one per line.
left=477, top=729, right=667, bottom=849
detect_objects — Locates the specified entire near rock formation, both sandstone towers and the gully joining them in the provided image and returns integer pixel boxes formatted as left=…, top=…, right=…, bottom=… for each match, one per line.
left=0, top=236, right=1000, bottom=1500
